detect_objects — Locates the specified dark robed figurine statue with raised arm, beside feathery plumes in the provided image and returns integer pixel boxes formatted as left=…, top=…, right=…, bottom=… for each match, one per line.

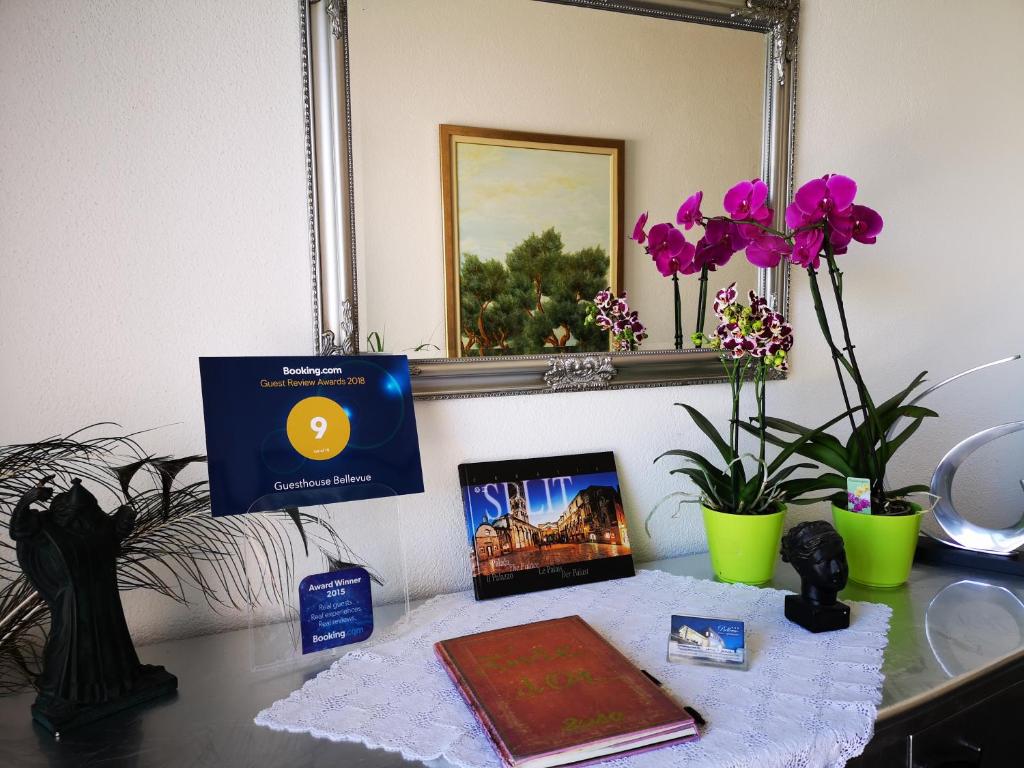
left=10, top=475, right=178, bottom=734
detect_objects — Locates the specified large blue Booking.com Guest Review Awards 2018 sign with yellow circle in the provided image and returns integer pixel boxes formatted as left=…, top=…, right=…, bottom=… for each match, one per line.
left=199, top=355, right=423, bottom=516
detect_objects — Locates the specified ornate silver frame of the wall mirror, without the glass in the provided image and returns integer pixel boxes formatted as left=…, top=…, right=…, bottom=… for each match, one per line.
left=299, top=0, right=800, bottom=398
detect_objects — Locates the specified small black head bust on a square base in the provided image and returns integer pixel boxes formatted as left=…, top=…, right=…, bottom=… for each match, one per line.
left=782, top=520, right=850, bottom=632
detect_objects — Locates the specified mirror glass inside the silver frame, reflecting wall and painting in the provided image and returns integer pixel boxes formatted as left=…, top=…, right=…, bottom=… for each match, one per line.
left=348, top=0, right=768, bottom=357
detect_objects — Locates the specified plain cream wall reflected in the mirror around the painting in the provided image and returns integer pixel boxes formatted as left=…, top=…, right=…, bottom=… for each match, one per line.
left=349, top=0, right=766, bottom=356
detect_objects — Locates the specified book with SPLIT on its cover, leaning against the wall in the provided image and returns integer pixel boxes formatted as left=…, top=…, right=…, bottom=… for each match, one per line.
left=459, top=453, right=635, bottom=600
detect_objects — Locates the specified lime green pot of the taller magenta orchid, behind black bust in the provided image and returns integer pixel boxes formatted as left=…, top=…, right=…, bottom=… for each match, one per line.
left=833, top=504, right=925, bottom=587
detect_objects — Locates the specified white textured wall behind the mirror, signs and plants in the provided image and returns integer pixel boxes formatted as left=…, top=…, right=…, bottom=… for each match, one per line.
left=0, top=0, right=1024, bottom=640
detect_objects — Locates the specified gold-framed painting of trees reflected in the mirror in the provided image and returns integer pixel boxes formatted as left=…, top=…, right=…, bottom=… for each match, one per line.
left=440, top=125, right=625, bottom=357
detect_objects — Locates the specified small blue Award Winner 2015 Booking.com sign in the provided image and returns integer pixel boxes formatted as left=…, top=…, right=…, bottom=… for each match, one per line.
left=299, top=568, right=374, bottom=653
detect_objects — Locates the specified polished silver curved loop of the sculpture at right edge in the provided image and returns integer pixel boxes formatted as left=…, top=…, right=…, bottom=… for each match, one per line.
left=931, top=421, right=1024, bottom=555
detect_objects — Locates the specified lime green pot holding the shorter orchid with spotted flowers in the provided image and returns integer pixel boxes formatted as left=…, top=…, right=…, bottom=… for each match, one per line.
left=700, top=505, right=785, bottom=584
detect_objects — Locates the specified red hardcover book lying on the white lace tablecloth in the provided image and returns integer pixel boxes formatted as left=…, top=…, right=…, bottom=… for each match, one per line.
left=434, top=616, right=697, bottom=768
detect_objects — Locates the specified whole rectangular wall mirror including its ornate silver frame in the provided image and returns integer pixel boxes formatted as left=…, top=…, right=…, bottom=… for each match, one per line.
left=302, top=0, right=797, bottom=397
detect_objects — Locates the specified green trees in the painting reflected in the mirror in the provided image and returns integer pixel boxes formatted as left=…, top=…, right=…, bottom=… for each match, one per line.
left=460, top=227, right=609, bottom=356
